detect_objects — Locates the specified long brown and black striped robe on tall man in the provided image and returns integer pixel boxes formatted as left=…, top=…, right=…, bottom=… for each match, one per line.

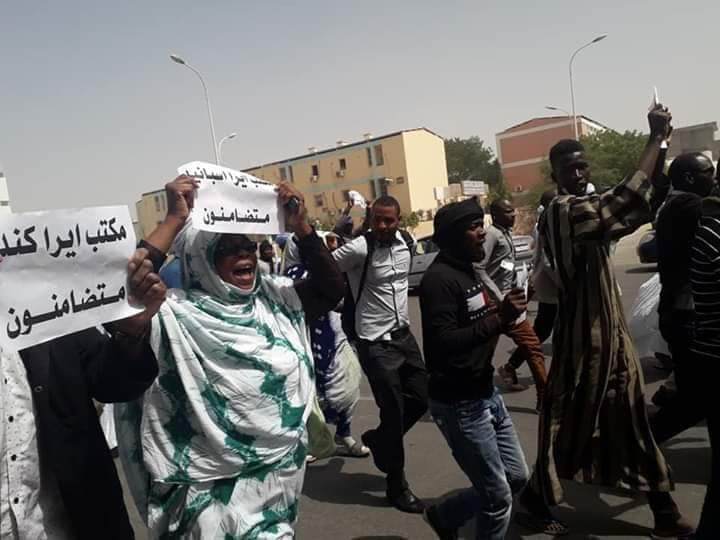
left=532, top=172, right=672, bottom=504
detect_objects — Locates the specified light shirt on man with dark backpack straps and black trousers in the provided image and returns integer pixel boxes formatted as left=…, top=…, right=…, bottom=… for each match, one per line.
left=333, top=233, right=410, bottom=341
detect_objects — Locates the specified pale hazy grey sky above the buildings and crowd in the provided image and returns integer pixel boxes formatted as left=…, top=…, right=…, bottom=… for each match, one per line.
left=0, top=0, right=720, bottom=217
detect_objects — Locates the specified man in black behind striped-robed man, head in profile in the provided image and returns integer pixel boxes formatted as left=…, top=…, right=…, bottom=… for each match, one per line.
left=651, top=152, right=717, bottom=443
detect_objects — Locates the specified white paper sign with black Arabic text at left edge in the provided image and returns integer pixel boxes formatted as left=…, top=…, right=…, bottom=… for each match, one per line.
left=0, top=206, right=141, bottom=351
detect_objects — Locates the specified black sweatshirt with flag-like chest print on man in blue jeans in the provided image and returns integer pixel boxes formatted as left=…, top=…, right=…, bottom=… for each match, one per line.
left=420, top=251, right=501, bottom=403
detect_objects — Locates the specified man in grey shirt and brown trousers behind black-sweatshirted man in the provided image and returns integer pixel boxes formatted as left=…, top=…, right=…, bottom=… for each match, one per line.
left=473, top=199, right=547, bottom=407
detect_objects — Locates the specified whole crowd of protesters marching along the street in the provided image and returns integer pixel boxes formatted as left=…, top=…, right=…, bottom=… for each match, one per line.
left=0, top=106, right=720, bottom=540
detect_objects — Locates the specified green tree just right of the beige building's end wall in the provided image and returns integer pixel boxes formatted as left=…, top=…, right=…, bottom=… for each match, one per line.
left=445, top=136, right=502, bottom=188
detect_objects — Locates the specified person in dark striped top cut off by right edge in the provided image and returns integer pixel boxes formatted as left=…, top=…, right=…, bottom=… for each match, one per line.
left=678, top=191, right=720, bottom=540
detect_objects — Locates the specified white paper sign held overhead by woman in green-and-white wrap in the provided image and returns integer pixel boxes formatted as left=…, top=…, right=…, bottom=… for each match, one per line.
left=178, top=161, right=285, bottom=234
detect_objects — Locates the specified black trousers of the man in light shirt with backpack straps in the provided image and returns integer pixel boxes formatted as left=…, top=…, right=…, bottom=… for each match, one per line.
left=358, top=331, right=428, bottom=481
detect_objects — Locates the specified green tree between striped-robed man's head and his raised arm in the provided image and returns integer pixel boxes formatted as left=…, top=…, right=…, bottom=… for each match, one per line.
left=580, top=130, right=647, bottom=191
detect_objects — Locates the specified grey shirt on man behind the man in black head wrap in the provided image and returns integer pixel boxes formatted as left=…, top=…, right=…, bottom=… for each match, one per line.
left=473, top=221, right=515, bottom=302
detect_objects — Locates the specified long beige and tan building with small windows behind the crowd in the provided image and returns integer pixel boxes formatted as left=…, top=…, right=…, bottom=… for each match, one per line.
left=245, top=128, right=448, bottom=224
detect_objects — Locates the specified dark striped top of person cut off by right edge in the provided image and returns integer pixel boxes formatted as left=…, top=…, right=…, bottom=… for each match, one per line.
left=690, top=205, right=720, bottom=359
